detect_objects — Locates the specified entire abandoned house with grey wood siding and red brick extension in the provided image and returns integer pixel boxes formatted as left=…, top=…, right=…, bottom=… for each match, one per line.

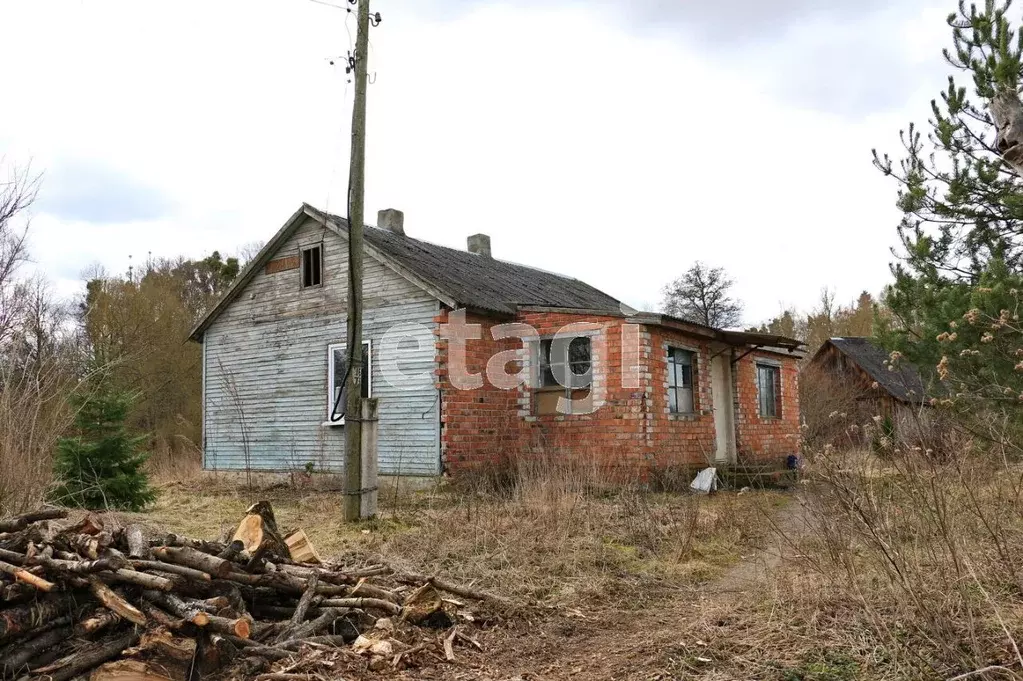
left=191, top=205, right=802, bottom=475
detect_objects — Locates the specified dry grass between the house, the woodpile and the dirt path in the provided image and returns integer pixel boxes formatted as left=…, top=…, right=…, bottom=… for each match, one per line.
left=131, top=456, right=787, bottom=607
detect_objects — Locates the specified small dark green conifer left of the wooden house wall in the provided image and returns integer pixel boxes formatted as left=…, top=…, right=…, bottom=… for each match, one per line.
left=52, top=389, right=155, bottom=510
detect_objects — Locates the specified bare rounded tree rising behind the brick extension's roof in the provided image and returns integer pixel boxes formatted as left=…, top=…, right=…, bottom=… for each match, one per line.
left=661, top=262, right=743, bottom=328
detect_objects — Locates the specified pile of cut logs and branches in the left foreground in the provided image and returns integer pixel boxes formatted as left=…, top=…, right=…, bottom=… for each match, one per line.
left=0, top=502, right=508, bottom=681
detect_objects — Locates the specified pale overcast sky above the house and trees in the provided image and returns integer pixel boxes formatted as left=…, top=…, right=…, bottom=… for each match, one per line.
left=0, top=0, right=954, bottom=323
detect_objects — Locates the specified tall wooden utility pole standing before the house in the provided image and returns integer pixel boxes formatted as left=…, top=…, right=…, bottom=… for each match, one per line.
left=345, top=0, right=369, bottom=521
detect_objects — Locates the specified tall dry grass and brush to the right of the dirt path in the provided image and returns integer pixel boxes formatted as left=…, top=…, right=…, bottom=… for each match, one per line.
left=667, top=450, right=1023, bottom=681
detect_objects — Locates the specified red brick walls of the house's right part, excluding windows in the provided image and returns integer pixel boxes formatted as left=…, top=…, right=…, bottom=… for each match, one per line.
left=437, top=312, right=799, bottom=472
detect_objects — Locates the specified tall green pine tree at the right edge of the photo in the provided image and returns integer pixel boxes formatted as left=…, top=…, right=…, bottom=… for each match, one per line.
left=874, top=0, right=1023, bottom=408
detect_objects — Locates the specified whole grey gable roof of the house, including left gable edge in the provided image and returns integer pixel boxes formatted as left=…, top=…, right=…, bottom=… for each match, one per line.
left=188, top=203, right=621, bottom=341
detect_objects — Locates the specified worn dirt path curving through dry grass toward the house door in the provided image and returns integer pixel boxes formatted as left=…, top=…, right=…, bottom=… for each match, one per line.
left=464, top=496, right=806, bottom=681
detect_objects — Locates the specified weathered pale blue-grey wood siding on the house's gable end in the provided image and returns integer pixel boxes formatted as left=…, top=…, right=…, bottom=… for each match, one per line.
left=204, top=220, right=440, bottom=474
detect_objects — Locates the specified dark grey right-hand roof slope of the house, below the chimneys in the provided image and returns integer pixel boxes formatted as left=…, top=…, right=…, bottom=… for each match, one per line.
left=324, top=206, right=620, bottom=314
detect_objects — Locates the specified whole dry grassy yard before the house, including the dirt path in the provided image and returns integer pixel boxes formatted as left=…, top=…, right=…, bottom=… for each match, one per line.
left=123, top=445, right=1023, bottom=681
